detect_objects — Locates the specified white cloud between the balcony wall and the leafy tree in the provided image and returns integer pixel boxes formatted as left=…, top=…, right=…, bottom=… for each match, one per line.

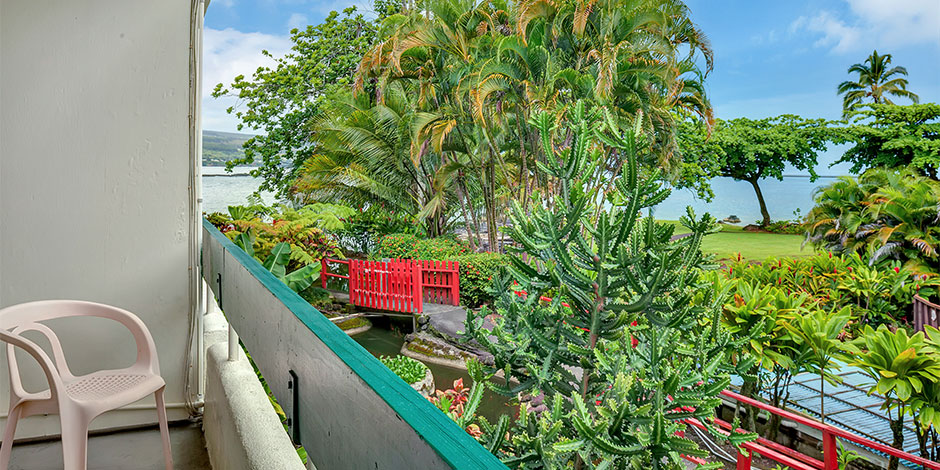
left=202, top=28, right=291, bottom=132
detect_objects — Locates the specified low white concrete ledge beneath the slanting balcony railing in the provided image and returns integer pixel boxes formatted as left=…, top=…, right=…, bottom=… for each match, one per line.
left=202, top=313, right=304, bottom=470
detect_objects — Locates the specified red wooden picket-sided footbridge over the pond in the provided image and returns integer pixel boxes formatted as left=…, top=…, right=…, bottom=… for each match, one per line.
left=320, top=258, right=460, bottom=313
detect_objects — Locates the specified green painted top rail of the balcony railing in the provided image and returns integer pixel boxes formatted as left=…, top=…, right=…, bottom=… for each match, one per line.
left=202, top=219, right=507, bottom=469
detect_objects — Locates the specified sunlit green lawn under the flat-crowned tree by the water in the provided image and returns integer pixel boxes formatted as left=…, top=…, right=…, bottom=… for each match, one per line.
left=660, top=220, right=813, bottom=261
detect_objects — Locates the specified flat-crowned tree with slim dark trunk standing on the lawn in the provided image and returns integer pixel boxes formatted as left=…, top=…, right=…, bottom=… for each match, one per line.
left=679, top=114, right=835, bottom=225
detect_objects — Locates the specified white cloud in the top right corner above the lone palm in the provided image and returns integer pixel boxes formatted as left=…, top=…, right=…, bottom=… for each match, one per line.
left=790, top=0, right=940, bottom=53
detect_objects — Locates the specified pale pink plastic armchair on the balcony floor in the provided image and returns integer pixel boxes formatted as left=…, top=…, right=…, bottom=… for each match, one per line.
left=0, top=300, right=173, bottom=470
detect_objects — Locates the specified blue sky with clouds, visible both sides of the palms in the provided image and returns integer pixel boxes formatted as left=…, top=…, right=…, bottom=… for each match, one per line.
left=203, top=0, right=940, bottom=173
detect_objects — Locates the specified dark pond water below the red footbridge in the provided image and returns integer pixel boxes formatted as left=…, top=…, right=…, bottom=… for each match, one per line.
left=352, top=318, right=516, bottom=423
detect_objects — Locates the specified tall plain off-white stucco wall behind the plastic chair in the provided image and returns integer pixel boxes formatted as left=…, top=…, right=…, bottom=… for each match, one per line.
left=0, top=0, right=191, bottom=438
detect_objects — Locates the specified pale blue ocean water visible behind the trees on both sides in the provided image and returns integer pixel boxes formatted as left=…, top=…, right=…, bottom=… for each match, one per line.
left=202, top=167, right=835, bottom=224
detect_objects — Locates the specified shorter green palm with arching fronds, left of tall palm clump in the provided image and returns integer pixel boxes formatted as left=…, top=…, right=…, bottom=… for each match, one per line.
left=295, top=85, right=454, bottom=236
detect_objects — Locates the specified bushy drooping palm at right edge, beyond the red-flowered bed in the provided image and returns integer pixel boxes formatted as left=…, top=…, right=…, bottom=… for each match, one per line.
left=806, top=169, right=940, bottom=275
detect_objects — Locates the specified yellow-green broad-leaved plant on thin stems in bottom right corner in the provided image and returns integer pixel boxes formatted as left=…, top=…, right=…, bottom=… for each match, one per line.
left=846, top=325, right=940, bottom=470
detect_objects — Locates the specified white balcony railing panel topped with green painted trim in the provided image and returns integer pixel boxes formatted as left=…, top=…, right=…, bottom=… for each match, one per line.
left=202, top=221, right=506, bottom=469
